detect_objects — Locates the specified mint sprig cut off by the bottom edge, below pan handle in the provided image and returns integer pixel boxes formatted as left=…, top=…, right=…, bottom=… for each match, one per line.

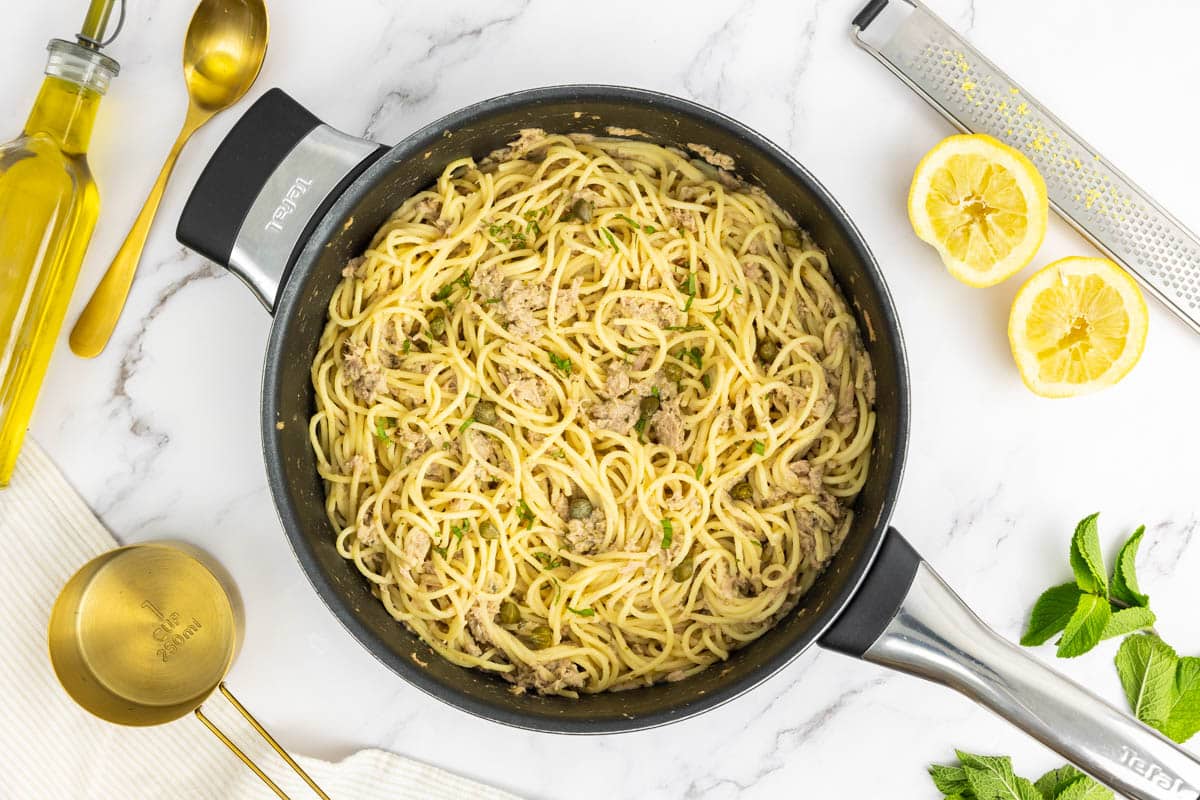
left=929, top=750, right=1112, bottom=800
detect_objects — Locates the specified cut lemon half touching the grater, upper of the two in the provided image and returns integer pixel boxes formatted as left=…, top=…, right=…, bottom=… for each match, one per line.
left=908, top=133, right=1049, bottom=287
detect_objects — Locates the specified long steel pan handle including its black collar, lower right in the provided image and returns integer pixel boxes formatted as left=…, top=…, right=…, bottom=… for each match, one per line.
left=821, top=530, right=1200, bottom=800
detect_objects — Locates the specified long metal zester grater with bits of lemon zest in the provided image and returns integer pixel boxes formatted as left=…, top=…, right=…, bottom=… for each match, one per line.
left=851, top=0, right=1200, bottom=332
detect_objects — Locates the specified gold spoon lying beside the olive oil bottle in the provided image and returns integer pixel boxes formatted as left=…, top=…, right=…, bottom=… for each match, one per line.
left=71, top=0, right=268, bottom=359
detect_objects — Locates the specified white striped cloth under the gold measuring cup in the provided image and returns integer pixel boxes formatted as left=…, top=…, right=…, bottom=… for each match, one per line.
left=0, top=440, right=517, bottom=800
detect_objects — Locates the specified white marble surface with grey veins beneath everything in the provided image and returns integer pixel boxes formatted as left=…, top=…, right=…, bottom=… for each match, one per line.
left=0, top=0, right=1200, bottom=798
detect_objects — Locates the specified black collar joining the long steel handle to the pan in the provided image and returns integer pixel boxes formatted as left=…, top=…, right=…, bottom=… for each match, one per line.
left=818, top=528, right=922, bottom=658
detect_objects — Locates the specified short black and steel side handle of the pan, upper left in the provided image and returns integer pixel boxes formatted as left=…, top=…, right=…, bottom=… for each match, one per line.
left=175, top=89, right=385, bottom=312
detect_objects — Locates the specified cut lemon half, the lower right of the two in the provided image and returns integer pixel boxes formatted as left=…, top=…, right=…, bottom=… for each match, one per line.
left=1008, top=258, right=1147, bottom=397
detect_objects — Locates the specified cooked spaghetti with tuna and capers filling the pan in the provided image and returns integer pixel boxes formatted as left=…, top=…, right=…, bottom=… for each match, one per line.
left=311, top=131, right=875, bottom=696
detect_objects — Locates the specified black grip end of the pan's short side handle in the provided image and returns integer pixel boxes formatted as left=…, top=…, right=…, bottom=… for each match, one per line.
left=175, top=89, right=322, bottom=266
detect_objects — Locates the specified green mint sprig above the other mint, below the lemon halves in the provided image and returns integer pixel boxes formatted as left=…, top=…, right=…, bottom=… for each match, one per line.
left=1021, top=513, right=1154, bottom=658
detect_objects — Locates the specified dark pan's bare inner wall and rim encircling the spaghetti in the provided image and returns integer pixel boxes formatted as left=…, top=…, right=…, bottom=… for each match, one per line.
left=262, top=86, right=908, bottom=733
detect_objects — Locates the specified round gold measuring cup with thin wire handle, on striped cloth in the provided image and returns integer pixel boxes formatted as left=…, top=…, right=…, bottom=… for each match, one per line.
left=49, top=543, right=329, bottom=800
